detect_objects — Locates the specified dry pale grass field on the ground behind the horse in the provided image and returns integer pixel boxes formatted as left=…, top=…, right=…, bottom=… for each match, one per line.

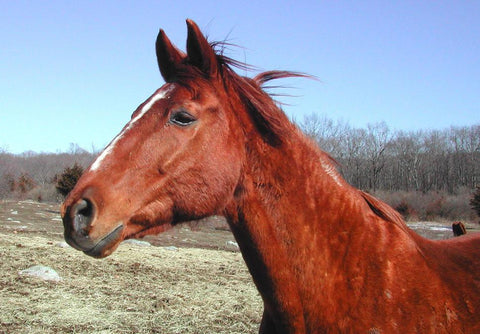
left=0, top=201, right=480, bottom=333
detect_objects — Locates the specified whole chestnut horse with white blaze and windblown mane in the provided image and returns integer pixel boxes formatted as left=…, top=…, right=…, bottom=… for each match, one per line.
left=62, top=20, right=480, bottom=333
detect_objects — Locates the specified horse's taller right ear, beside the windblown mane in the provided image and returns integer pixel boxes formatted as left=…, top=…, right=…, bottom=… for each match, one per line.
left=187, top=19, right=218, bottom=76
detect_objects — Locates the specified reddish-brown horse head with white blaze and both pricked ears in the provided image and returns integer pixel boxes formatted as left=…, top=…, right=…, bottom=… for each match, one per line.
left=62, top=20, right=244, bottom=257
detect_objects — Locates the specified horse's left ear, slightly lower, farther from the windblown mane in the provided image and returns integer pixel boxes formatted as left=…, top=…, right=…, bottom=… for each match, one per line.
left=155, top=29, right=185, bottom=82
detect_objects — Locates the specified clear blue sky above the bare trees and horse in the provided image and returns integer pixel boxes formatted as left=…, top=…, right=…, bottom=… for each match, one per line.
left=0, top=0, right=480, bottom=153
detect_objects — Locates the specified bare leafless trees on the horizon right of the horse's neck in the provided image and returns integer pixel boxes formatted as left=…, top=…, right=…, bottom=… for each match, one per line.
left=300, top=114, right=480, bottom=194
